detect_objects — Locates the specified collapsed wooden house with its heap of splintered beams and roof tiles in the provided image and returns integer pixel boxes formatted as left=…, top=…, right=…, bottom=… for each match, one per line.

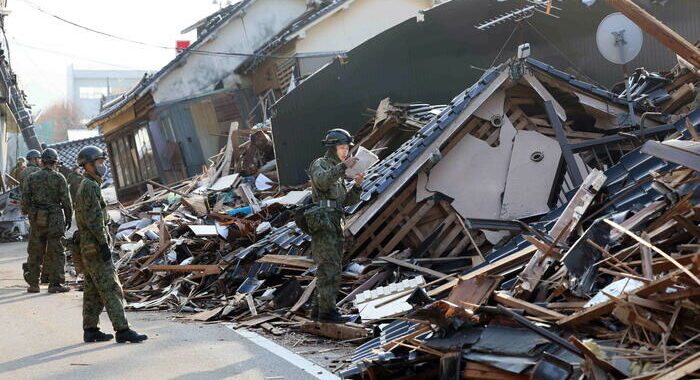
left=67, top=53, right=700, bottom=379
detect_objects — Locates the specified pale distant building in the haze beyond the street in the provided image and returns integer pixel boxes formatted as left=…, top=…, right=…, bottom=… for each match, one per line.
left=67, top=65, right=146, bottom=124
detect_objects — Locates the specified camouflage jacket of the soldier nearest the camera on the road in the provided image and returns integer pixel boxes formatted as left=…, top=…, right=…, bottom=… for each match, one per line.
left=75, top=173, right=109, bottom=245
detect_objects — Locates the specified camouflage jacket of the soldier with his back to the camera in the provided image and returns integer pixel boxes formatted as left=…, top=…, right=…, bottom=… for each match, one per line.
left=22, top=168, right=73, bottom=220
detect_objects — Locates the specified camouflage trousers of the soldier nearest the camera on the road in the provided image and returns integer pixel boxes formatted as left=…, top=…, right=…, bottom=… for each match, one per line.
left=80, top=235, right=129, bottom=331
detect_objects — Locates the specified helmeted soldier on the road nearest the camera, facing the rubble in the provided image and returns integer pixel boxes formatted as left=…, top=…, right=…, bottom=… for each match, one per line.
left=75, top=146, right=147, bottom=343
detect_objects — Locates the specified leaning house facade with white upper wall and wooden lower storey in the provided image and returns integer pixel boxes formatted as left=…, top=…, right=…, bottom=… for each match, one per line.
left=87, top=0, right=308, bottom=200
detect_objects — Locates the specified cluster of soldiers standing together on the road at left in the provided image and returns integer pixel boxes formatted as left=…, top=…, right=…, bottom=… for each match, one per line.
left=10, top=146, right=147, bottom=343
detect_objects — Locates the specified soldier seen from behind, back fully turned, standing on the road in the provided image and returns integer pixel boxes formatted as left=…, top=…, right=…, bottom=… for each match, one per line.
left=22, top=148, right=73, bottom=293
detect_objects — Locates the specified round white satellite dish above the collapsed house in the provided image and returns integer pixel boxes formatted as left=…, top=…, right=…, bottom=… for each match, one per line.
left=596, top=12, right=644, bottom=65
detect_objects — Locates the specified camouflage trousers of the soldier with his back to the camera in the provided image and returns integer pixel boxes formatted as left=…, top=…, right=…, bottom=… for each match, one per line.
left=24, top=220, right=66, bottom=285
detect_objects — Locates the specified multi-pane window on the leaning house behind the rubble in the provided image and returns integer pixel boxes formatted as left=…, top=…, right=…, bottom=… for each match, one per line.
left=110, top=125, right=158, bottom=187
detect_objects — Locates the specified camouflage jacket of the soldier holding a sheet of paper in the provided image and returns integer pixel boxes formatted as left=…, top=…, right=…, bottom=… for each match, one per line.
left=309, top=152, right=362, bottom=206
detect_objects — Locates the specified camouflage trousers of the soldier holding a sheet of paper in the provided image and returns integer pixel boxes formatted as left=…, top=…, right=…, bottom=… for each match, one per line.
left=311, top=212, right=344, bottom=313
